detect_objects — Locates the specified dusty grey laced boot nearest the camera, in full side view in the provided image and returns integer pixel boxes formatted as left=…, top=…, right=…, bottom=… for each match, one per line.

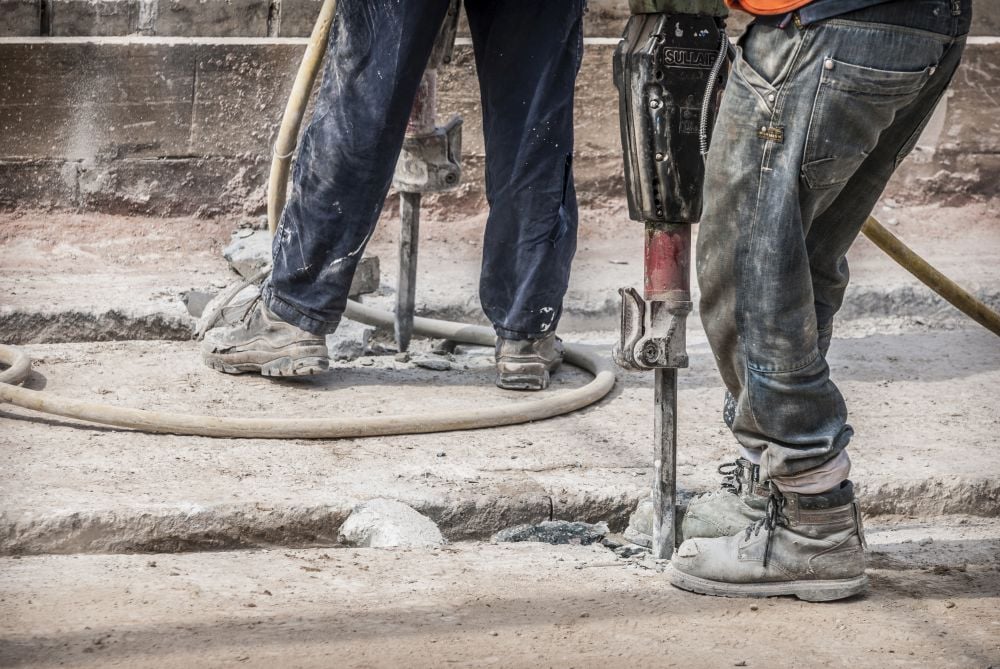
left=670, top=481, right=868, bottom=602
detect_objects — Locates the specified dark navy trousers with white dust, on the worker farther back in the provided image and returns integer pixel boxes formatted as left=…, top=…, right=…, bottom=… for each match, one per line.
left=264, top=0, right=584, bottom=339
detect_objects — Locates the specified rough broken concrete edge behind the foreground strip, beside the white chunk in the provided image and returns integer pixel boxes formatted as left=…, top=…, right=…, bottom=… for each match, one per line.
left=0, top=477, right=1000, bottom=555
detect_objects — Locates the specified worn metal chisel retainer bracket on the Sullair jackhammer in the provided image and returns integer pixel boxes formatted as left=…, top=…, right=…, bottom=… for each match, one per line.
left=612, top=288, right=691, bottom=370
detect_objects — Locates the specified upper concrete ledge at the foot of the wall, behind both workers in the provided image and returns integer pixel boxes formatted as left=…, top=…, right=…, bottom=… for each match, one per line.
left=0, top=194, right=1000, bottom=343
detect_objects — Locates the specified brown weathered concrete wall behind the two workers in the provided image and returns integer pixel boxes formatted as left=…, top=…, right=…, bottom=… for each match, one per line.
left=0, top=0, right=1000, bottom=215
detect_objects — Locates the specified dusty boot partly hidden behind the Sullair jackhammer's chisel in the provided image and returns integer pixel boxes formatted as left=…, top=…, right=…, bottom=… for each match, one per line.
left=625, top=458, right=770, bottom=548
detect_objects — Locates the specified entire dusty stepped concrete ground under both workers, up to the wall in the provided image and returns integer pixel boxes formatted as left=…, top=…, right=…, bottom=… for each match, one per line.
left=0, top=198, right=1000, bottom=668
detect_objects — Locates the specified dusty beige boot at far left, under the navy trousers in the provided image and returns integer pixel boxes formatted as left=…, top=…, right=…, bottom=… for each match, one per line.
left=202, top=298, right=330, bottom=376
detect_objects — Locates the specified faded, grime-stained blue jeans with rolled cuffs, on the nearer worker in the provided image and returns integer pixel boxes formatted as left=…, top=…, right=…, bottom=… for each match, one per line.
left=697, top=0, right=971, bottom=493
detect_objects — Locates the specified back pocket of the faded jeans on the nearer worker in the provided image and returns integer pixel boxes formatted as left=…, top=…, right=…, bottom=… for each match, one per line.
left=802, top=57, right=934, bottom=189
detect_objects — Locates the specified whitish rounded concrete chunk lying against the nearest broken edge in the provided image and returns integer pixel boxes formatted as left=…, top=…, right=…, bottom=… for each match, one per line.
left=338, top=498, right=445, bottom=548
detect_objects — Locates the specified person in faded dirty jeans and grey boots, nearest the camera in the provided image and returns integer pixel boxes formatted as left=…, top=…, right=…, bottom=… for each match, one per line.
left=633, top=0, right=971, bottom=601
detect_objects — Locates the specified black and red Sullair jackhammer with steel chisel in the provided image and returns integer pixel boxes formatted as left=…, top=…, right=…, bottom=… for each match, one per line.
left=614, top=0, right=729, bottom=558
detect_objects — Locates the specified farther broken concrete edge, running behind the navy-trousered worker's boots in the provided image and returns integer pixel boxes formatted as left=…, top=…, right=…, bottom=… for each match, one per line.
left=0, top=282, right=1000, bottom=345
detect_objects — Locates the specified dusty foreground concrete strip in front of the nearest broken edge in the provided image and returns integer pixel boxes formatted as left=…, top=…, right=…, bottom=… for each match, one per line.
left=0, top=516, right=1000, bottom=669
